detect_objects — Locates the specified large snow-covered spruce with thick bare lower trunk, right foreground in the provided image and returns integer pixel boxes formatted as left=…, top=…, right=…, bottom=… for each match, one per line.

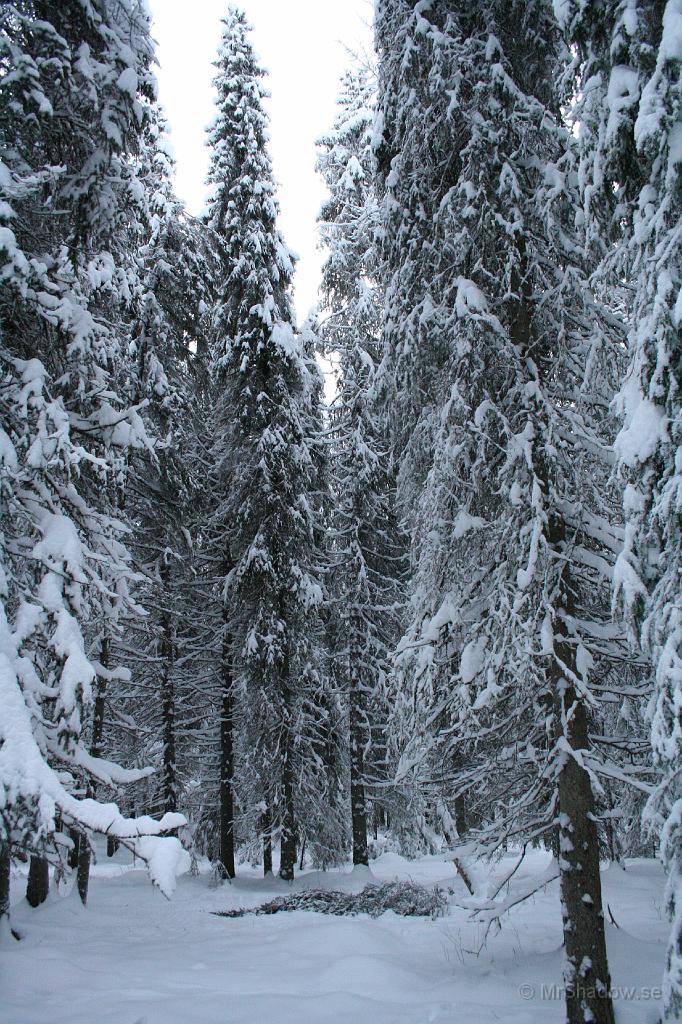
left=376, top=0, right=642, bottom=1024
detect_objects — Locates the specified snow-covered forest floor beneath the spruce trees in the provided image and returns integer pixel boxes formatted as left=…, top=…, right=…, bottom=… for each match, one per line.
left=0, top=851, right=668, bottom=1024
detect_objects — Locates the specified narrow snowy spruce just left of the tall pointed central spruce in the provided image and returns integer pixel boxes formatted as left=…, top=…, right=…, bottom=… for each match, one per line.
left=109, top=104, right=213, bottom=827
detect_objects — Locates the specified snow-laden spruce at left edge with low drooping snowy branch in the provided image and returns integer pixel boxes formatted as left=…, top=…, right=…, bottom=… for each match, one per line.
left=0, top=0, right=182, bottom=913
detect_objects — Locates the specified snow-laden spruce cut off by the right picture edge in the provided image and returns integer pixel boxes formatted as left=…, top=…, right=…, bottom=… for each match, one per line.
left=557, top=0, right=682, bottom=1020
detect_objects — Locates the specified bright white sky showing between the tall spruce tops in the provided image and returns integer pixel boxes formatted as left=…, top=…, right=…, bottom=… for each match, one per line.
left=148, top=0, right=374, bottom=318
